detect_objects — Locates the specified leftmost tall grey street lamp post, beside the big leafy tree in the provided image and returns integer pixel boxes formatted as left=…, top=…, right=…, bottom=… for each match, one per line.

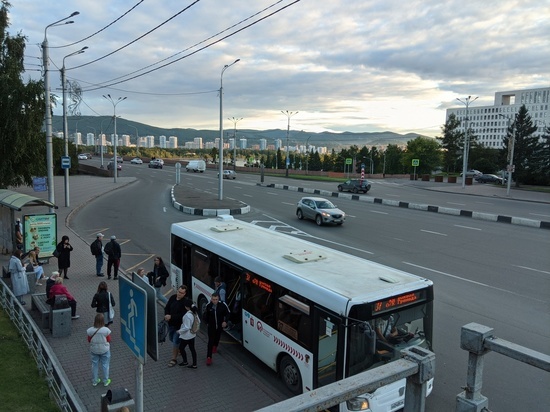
left=42, top=11, right=80, bottom=212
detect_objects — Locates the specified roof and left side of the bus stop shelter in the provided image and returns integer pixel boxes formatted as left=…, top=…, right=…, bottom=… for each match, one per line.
left=0, top=189, right=57, bottom=254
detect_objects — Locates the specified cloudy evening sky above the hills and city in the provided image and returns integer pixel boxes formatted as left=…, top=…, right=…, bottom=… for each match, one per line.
left=8, top=0, right=550, bottom=136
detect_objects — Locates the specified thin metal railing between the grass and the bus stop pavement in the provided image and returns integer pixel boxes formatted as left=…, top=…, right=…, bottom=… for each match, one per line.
left=0, top=279, right=86, bottom=412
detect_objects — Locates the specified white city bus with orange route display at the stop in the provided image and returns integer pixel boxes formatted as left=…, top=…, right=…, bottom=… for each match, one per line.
left=171, top=216, right=433, bottom=411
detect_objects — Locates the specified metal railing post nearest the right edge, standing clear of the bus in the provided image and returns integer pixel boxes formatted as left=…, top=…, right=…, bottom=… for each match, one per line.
left=455, top=323, right=493, bottom=412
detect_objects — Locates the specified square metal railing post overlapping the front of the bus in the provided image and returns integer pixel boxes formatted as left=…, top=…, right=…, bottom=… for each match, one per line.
left=401, top=346, right=435, bottom=412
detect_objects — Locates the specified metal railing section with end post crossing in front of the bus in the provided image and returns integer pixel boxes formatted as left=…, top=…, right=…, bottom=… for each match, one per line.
left=259, top=346, right=435, bottom=412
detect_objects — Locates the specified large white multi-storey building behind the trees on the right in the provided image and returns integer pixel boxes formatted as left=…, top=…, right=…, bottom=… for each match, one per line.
left=446, top=87, right=550, bottom=149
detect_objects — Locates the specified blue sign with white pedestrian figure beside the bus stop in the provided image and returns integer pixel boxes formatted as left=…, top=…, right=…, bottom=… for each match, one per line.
left=119, top=276, right=147, bottom=364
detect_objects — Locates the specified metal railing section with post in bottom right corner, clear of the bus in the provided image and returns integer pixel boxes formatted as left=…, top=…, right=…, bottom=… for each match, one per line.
left=455, top=323, right=550, bottom=412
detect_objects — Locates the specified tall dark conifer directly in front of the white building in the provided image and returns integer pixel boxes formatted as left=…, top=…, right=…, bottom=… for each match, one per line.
left=501, top=105, right=539, bottom=187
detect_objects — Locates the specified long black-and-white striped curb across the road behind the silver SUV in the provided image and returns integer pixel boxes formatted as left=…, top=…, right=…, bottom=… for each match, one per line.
left=262, top=183, right=550, bottom=229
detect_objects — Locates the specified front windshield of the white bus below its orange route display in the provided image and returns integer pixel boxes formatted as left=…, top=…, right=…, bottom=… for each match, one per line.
left=347, top=303, right=432, bottom=376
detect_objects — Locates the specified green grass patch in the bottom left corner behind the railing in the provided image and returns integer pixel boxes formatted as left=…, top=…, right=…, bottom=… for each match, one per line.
left=0, top=309, right=59, bottom=412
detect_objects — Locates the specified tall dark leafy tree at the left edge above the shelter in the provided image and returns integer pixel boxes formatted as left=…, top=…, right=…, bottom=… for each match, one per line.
left=0, top=0, right=46, bottom=188
